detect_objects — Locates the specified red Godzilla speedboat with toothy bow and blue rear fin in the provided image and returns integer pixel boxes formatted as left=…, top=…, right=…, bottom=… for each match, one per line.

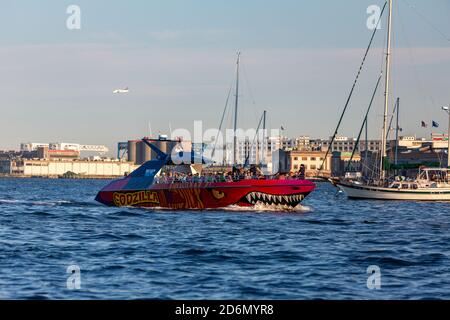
left=96, top=139, right=315, bottom=209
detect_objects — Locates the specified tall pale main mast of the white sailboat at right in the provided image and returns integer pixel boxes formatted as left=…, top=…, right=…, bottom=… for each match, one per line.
left=380, top=0, right=393, bottom=181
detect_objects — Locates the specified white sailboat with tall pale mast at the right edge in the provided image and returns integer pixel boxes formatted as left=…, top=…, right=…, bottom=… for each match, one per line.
left=332, top=0, right=450, bottom=201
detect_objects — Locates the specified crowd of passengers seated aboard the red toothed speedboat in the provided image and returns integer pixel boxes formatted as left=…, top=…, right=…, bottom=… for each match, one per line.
left=154, top=168, right=305, bottom=183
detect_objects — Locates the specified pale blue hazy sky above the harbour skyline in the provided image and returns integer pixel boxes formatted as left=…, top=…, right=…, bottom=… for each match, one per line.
left=0, top=0, right=450, bottom=152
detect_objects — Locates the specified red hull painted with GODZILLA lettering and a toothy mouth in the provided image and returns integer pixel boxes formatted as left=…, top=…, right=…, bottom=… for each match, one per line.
left=96, top=178, right=315, bottom=209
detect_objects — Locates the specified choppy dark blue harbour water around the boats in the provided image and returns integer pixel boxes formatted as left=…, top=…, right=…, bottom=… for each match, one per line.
left=0, top=179, right=450, bottom=299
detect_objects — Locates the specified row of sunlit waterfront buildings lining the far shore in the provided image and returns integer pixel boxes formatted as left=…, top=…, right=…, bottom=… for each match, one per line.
left=0, top=134, right=448, bottom=178
